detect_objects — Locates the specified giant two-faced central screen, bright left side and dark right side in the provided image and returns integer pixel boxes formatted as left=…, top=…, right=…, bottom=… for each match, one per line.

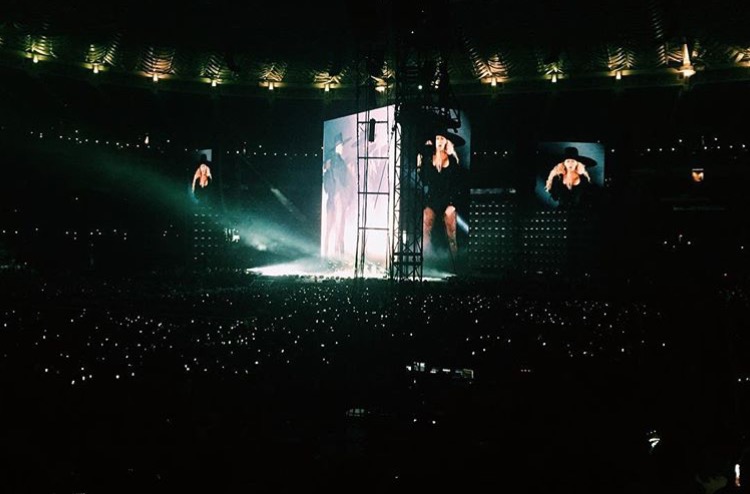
left=320, top=105, right=471, bottom=271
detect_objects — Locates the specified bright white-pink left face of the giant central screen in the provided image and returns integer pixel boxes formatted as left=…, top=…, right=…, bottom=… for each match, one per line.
left=320, top=105, right=396, bottom=267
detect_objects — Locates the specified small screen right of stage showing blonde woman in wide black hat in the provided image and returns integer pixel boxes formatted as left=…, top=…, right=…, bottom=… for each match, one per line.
left=535, top=142, right=605, bottom=209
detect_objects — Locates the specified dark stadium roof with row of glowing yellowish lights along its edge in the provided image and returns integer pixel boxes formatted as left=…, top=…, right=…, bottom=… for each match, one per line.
left=0, top=0, right=750, bottom=98
